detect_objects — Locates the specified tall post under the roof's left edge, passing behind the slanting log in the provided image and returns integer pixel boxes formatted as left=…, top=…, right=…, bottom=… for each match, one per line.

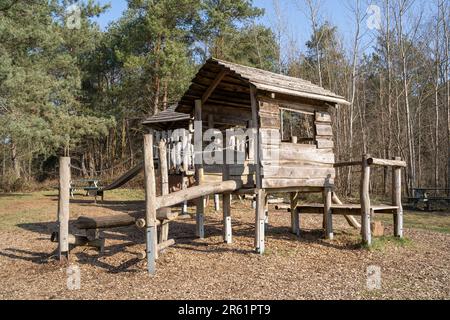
left=195, top=100, right=205, bottom=239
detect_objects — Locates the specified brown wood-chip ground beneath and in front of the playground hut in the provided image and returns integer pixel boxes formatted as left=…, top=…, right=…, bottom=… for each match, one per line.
left=0, top=191, right=450, bottom=300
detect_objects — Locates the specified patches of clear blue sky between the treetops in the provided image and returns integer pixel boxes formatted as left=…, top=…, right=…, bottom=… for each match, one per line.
left=91, top=0, right=380, bottom=53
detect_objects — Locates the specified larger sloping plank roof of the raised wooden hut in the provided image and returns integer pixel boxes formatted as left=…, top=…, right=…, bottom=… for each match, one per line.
left=176, top=58, right=349, bottom=113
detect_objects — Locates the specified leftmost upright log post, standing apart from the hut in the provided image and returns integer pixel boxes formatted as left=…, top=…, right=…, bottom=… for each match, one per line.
left=58, top=157, right=71, bottom=262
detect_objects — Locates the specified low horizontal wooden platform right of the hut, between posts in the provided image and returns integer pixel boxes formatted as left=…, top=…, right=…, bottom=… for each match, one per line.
left=297, top=204, right=398, bottom=216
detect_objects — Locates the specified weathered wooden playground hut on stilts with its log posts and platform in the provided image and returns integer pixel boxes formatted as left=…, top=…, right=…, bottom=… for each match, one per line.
left=52, top=59, right=406, bottom=274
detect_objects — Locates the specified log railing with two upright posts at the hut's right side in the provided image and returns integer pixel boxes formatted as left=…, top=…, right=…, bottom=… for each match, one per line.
left=334, top=155, right=406, bottom=244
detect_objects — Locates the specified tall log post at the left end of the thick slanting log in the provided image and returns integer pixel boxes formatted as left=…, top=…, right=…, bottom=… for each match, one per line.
left=144, top=130, right=158, bottom=275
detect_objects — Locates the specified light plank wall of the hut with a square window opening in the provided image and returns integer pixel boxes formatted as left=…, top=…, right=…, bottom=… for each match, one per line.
left=260, top=102, right=336, bottom=189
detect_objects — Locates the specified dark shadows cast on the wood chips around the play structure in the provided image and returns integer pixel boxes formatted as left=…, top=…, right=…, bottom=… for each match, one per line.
left=0, top=196, right=361, bottom=273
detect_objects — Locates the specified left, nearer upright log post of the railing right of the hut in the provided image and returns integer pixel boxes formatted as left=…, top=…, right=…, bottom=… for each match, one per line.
left=360, top=155, right=372, bottom=246
